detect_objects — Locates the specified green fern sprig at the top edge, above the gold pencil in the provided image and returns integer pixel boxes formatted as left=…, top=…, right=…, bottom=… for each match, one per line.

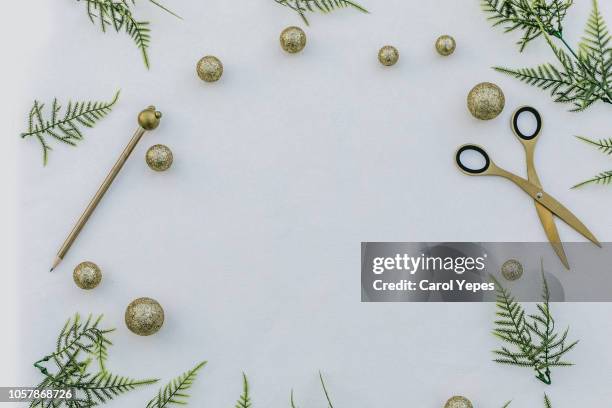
left=77, top=0, right=181, bottom=69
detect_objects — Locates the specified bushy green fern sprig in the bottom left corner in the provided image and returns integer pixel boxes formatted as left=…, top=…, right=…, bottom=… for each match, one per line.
left=30, top=314, right=158, bottom=408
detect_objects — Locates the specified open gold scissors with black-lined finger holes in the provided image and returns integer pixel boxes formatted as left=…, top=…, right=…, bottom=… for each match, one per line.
left=455, top=106, right=601, bottom=269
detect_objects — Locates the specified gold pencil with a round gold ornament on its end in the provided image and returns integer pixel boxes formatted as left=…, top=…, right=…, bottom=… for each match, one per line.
left=49, top=106, right=162, bottom=272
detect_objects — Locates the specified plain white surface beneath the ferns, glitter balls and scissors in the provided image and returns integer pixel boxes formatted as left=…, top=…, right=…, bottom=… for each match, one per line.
left=1, top=0, right=612, bottom=408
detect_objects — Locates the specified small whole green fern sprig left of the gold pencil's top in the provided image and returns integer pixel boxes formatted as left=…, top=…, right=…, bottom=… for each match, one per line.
left=21, top=91, right=119, bottom=165
